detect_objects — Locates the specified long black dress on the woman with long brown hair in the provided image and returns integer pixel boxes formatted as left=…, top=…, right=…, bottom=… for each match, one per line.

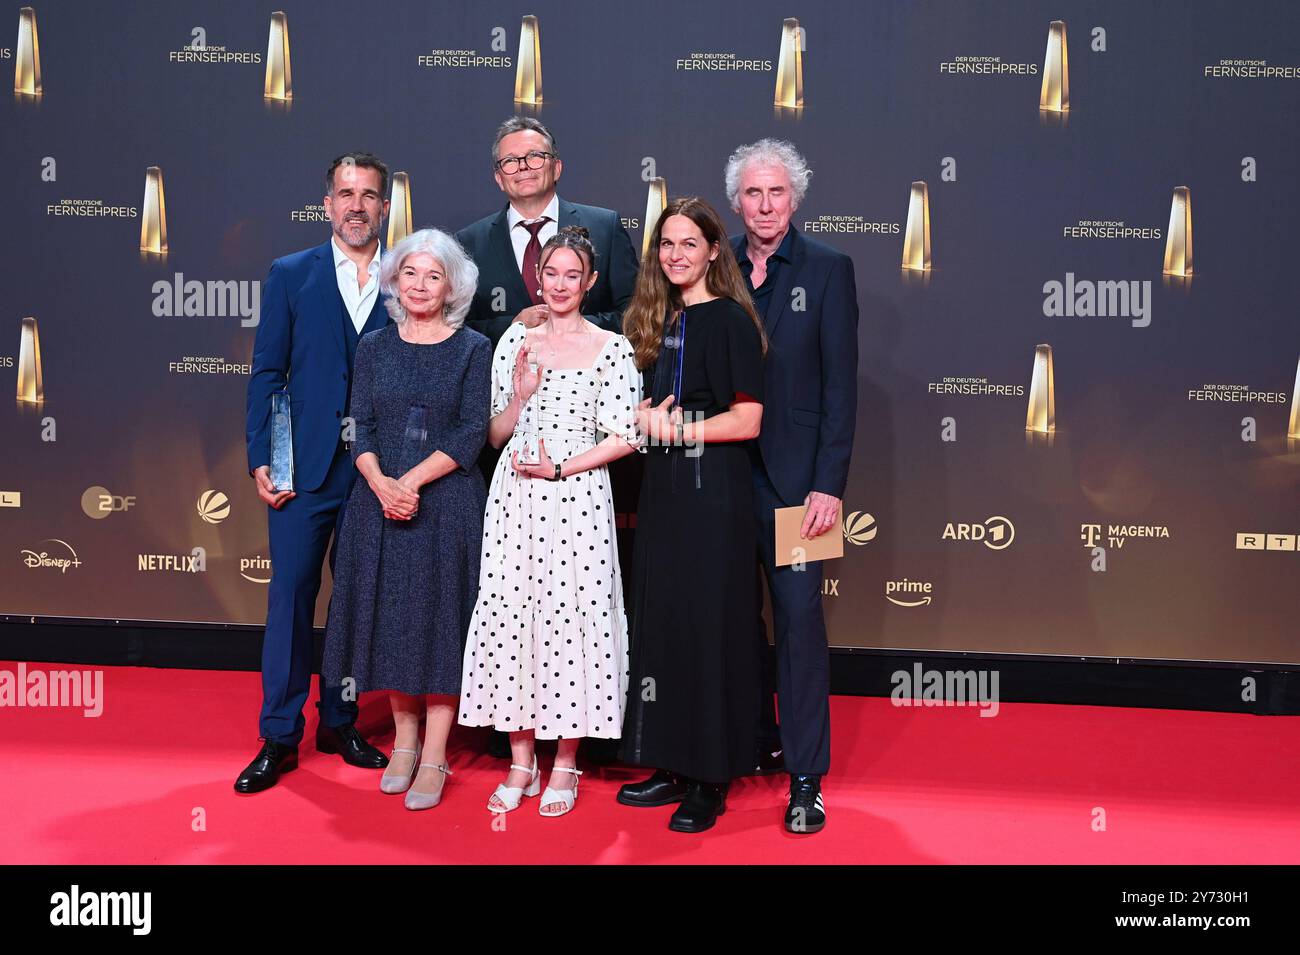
left=621, top=299, right=763, bottom=783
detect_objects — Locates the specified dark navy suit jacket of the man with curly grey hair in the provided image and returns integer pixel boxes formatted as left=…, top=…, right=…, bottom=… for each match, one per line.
left=731, top=225, right=858, bottom=507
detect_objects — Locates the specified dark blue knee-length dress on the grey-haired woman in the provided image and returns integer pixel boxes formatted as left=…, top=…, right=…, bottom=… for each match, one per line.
left=321, top=325, right=491, bottom=695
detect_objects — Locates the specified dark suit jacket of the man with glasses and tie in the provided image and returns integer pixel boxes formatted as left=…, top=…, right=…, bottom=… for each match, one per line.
left=456, top=199, right=640, bottom=348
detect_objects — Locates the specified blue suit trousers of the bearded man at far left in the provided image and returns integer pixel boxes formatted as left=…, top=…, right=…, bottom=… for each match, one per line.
left=259, top=450, right=356, bottom=746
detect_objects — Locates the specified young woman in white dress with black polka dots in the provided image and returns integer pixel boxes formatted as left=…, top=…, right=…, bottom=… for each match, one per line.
left=460, top=226, right=641, bottom=816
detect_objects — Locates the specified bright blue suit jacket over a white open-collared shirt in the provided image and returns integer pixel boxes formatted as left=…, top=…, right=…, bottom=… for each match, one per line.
left=246, top=242, right=390, bottom=491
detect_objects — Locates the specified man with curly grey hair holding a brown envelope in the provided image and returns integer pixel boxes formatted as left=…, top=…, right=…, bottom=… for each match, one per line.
left=725, top=139, right=858, bottom=833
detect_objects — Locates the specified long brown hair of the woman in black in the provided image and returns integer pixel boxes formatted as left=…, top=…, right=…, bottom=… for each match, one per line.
left=623, top=196, right=767, bottom=369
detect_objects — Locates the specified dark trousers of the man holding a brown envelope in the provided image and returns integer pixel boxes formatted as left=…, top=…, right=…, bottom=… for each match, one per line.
left=754, top=461, right=835, bottom=776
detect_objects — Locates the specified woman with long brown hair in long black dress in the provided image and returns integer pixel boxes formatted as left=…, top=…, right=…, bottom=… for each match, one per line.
left=619, top=197, right=766, bottom=832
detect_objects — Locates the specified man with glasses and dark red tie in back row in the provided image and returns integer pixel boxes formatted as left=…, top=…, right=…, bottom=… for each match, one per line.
left=456, top=116, right=638, bottom=348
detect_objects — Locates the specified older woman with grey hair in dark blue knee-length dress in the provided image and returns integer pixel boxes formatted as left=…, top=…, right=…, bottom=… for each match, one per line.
left=321, top=229, right=491, bottom=809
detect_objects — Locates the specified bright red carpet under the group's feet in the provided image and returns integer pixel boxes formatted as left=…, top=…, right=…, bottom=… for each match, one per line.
left=0, top=663, right=1300, bottom=864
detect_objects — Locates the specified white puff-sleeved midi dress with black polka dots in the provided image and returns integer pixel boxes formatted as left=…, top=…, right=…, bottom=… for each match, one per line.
left=460, top=322, right=641, bottom=739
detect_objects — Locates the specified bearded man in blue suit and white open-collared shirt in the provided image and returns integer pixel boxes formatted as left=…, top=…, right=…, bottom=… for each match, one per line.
left=235, top=152, right=392, bottom=793
